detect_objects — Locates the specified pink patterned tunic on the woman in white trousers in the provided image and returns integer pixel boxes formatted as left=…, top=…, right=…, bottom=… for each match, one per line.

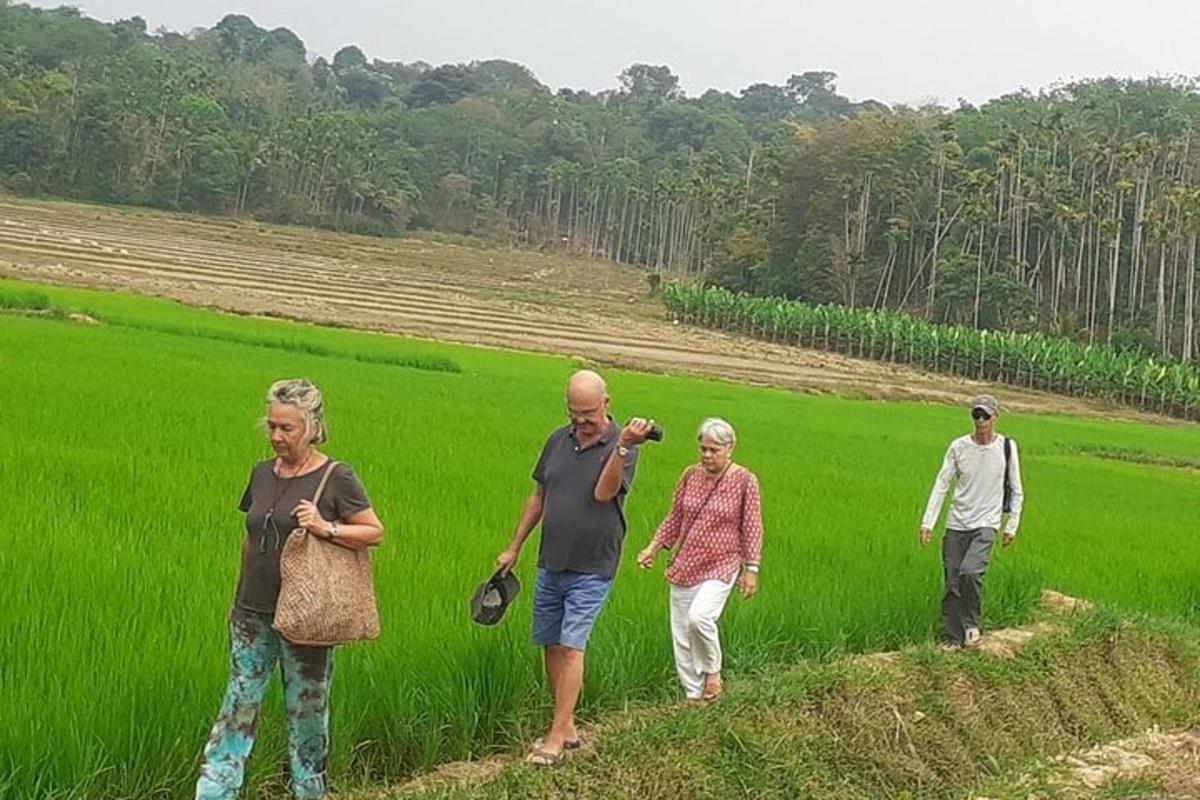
left=654, top=465, right=762, bottom=587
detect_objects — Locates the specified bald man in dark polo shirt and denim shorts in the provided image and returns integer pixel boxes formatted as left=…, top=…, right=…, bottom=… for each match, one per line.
left=496, top=369, right=654, bottom=766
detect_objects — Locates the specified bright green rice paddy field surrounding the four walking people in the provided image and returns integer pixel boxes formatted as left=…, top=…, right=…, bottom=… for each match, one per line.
left=0, top=281, right=1200, bottom=796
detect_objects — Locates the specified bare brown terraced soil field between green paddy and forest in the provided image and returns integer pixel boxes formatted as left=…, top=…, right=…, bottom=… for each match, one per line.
left=0, top=197, right=1166, bottom=417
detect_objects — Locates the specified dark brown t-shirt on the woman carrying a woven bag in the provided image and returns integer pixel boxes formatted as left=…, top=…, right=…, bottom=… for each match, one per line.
left=236, top=458, right=371, bottom=614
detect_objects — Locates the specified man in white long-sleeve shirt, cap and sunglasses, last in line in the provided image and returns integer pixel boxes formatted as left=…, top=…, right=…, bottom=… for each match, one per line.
left=920, top=395, right=1025, bottom=648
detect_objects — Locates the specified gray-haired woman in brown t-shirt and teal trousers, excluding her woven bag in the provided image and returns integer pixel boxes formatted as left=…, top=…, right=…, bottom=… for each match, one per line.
left=196, top=379, right=383, bottom=800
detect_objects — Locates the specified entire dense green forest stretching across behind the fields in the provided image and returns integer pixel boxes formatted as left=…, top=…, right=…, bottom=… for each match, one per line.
left=7, top=0, right=1200, bottom=360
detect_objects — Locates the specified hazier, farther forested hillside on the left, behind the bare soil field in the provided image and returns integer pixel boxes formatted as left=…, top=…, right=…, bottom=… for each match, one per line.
left=0, top=0, right=856, bottom=262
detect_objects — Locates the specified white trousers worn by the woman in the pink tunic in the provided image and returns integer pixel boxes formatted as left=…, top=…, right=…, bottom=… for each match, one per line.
left=671, top=581, right=736, bottom=699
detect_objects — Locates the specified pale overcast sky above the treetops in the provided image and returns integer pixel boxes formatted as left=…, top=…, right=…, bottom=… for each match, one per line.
left=23, top=0, right=1200, bottom=104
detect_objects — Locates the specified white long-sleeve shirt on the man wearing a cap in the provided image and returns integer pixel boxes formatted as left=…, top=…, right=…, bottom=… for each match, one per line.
left=920, top=435, right=1025, bottom=535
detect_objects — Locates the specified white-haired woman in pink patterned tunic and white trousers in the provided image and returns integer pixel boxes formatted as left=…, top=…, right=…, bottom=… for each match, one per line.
left=637, top=417, right=762, bottom=703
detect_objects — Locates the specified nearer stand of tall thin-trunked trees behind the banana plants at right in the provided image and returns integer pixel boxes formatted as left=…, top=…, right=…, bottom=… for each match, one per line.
left=753, top=85, right=1200, bottom=361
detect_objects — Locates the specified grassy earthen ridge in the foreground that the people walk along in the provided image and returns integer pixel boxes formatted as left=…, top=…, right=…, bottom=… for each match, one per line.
left=347, top=591, right=1200, bottom=800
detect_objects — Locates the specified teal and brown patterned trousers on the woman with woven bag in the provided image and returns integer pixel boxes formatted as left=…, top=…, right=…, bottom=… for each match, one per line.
left=196, top=608, right=332, bottom=800
